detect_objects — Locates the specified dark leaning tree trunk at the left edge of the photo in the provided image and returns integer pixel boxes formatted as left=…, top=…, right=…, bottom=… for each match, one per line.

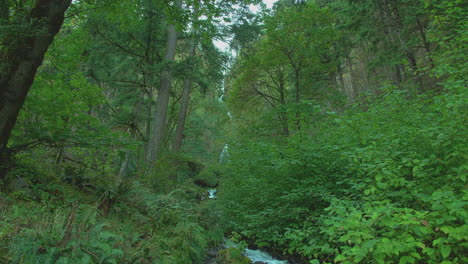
left=0, top=0, right=71, bottom=169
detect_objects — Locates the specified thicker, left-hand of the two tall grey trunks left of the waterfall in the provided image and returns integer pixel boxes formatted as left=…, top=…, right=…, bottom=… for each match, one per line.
left=146, top=0, right=182, bottom=167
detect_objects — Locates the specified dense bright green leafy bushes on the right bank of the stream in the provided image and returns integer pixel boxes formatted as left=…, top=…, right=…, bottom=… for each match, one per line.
left=219, top=83, right=468, bottom=263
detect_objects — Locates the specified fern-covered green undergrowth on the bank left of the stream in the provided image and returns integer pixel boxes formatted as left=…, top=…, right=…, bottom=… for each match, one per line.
left=0, top=156, right=223, bottom=264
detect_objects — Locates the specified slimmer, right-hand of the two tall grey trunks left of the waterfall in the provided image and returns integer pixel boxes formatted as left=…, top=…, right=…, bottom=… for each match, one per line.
left=172, top=8, right=198, bottom=152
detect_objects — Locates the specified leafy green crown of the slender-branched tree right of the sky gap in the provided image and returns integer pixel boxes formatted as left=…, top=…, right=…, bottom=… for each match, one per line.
left=228, top=2, right=339, bottom=135
